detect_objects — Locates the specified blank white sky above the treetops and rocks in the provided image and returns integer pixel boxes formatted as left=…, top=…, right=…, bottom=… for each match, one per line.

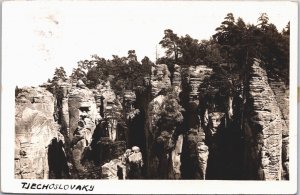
left=2, top=1, right=293, bottom=86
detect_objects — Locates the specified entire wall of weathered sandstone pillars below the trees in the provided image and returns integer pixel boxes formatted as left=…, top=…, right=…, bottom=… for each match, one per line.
left=15, top=60, right=289, bottom=180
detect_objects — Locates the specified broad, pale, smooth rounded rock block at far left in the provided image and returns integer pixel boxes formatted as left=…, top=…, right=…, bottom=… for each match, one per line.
left=15, top=87, right=67, bottom=179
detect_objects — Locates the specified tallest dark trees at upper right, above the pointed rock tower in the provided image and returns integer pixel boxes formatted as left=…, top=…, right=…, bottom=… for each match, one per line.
left=213, top=13, right=289, bottom=82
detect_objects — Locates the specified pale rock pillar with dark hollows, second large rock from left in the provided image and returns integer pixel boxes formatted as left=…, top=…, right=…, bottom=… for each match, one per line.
left=68, top=80, right=97, bottom=175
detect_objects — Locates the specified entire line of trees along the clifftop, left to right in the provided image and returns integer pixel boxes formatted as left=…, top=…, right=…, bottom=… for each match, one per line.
left=49, top=13, right=290, bottom=94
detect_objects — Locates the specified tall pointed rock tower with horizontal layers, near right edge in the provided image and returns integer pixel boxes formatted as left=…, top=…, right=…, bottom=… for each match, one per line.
left=244, top=59, right=285, bottom=180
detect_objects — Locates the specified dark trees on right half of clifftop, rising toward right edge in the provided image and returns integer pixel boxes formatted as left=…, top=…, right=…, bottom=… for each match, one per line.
left=158, top=13, right=290, bottom=80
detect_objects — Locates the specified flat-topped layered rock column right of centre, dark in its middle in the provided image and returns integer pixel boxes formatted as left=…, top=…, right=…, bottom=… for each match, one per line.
left=181, top=65, right=213, bottom=179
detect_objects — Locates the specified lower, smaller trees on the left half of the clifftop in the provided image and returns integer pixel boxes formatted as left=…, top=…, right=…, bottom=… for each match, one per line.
left=49, top=50, right=154, bottom=95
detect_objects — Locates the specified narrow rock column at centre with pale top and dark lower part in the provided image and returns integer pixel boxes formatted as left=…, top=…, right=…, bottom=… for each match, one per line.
left=146, top=64, right=171, bottom=179
